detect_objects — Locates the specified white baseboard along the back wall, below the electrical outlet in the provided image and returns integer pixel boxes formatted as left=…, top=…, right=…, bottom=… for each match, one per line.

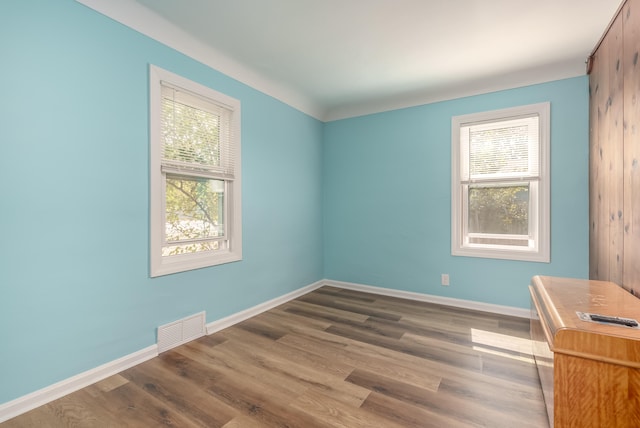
left=323, top=280, right=531, bottom=319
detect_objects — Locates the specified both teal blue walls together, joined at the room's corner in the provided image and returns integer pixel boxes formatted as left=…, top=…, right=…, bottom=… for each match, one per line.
left=0, top=0, right=588, bottom=403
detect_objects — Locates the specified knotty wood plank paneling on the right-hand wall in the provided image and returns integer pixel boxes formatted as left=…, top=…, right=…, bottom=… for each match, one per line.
left=587, top=0, right=640, bottom=293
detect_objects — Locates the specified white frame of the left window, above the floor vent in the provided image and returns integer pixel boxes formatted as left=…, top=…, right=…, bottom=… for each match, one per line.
left=149, top=64, right=242, bottom=277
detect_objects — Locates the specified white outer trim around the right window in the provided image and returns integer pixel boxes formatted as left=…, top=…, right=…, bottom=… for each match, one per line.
left=451, top=102, right=551, bottom=263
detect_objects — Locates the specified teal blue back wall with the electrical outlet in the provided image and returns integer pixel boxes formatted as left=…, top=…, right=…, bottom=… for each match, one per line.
left=324, top=77, right=589, bottom=308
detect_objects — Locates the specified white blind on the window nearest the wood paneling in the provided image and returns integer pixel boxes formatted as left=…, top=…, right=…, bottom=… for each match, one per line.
left=460, top=116, right=540, bottom=183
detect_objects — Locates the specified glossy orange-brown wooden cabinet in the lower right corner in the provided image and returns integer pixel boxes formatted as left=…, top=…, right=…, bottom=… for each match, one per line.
left=529, top=276, right=640, bottom=428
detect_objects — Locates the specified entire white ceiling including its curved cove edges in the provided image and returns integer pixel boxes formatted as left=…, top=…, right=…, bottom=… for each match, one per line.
left=78, top=0, right=621, bottom=120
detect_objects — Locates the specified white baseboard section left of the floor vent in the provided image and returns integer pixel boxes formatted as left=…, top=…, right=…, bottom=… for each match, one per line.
left=0, top=345, right=158, bottom=423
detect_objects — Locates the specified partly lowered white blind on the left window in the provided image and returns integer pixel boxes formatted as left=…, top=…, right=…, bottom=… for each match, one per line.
left=161, top=82, right=235, bottom=180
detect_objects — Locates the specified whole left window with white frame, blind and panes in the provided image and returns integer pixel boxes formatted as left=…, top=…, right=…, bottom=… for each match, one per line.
left=149, top=65, right=242, bottom=277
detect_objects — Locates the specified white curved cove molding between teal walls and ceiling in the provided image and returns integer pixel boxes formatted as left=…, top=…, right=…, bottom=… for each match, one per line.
left=76, top=0, right=585, bottom=122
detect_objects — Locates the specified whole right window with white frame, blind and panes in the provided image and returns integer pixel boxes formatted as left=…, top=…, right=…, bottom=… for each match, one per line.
left=451, top=103, right=550, bottom=262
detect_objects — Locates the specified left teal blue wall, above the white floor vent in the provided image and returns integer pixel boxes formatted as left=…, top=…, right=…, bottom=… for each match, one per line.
left=0, top=0, right=323, bottom=403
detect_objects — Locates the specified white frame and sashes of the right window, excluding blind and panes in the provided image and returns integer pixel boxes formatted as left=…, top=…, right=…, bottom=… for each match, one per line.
left=451, top=102, right=551, bottom=263
